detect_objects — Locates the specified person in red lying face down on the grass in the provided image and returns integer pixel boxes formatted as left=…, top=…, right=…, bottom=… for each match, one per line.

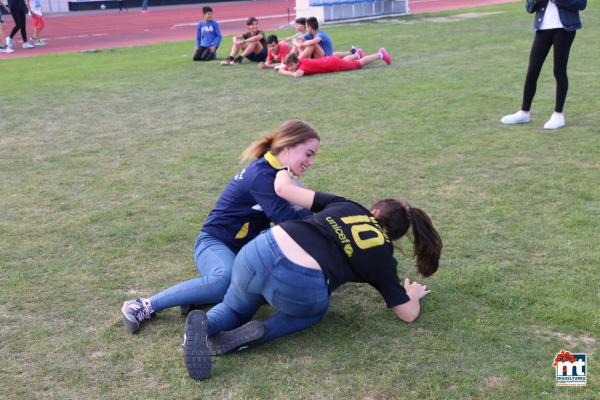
left=279, top=48, right=392, bottom=78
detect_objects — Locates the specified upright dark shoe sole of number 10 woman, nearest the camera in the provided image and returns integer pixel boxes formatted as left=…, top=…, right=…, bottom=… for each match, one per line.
left=183, top=310, right=212, bottom=381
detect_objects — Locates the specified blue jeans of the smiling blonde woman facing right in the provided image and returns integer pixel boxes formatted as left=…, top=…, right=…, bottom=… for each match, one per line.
left=150, top=232, right=235, bottom=312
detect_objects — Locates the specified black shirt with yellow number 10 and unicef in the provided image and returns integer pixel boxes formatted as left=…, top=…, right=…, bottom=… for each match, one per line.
left=280, top=192, right=410, bottom=307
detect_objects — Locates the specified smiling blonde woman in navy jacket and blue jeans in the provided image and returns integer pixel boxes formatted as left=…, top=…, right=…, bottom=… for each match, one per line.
left=121, top=120, right=320, bottom=333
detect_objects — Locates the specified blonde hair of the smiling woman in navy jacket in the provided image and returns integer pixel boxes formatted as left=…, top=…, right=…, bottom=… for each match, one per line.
left=241, top=119, right=321, bottom=162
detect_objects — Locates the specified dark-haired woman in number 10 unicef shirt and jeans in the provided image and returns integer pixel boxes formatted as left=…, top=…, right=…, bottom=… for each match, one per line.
left=184, top=170, right=442, bottom=380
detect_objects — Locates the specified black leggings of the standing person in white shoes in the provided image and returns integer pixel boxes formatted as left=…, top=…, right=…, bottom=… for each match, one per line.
left=521, top=28, right=575, bottom=112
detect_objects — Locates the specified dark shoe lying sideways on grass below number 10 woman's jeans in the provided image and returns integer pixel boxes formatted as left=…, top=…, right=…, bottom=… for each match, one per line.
left=208, top=321, right=265, bottom=356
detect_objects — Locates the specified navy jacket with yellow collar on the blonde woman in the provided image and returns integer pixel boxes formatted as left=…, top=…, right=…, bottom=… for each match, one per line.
left=196, top=152, right=312, bottom=253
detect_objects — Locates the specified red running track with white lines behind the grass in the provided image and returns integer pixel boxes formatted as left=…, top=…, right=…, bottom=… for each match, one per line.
left=0, top=0, right=517, bottom=59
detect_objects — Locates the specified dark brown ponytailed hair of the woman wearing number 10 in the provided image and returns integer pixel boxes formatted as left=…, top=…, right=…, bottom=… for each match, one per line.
left=371, top=199, right=442, bottom=277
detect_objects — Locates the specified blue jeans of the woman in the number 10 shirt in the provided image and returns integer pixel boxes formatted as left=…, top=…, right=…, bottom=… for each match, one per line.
left=208, top=230, right=329, bottom=341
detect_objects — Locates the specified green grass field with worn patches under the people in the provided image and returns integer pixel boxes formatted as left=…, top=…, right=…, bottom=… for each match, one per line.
left=0, top=0, right=600, bottom=400
